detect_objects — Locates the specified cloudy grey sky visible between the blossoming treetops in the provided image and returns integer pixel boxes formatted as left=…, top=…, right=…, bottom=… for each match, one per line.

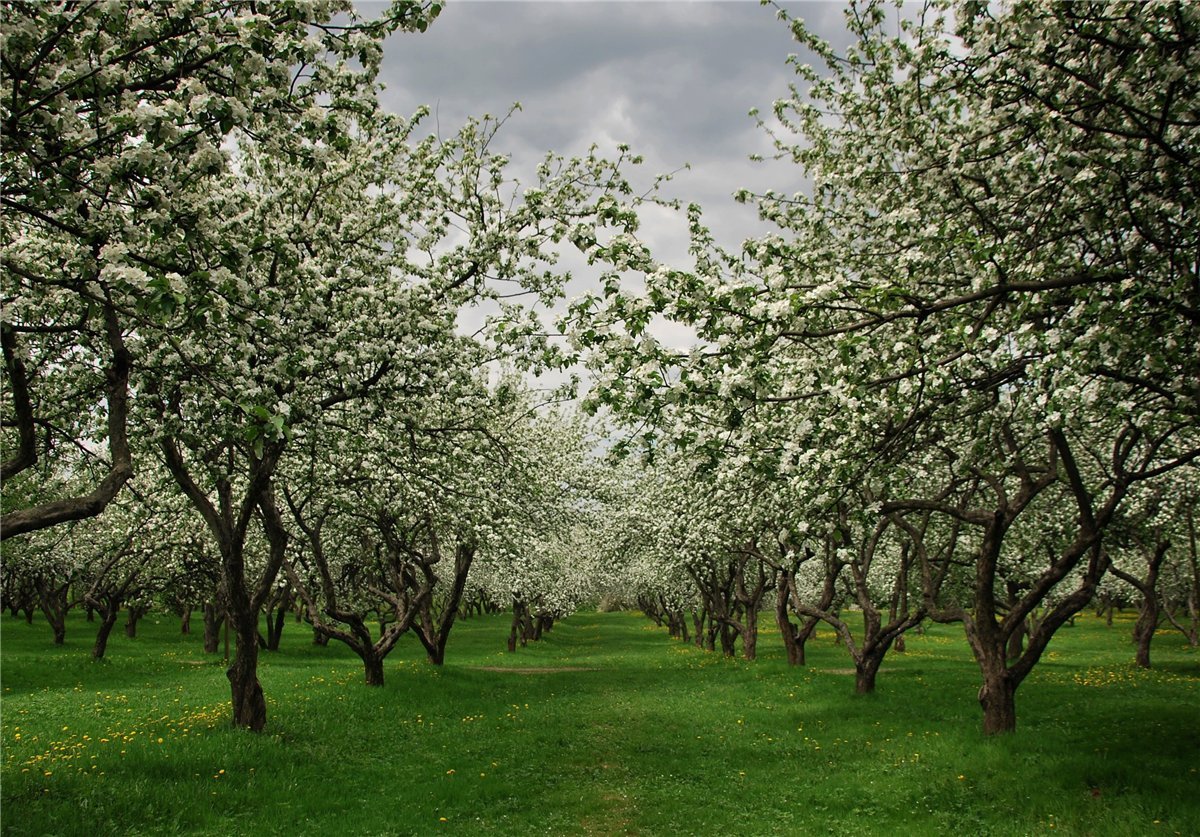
left=358, top=0, right=845, bottom=359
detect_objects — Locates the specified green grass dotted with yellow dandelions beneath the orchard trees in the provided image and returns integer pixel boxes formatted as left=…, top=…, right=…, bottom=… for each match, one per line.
left=0, top=606, right=1200, bottom=836
